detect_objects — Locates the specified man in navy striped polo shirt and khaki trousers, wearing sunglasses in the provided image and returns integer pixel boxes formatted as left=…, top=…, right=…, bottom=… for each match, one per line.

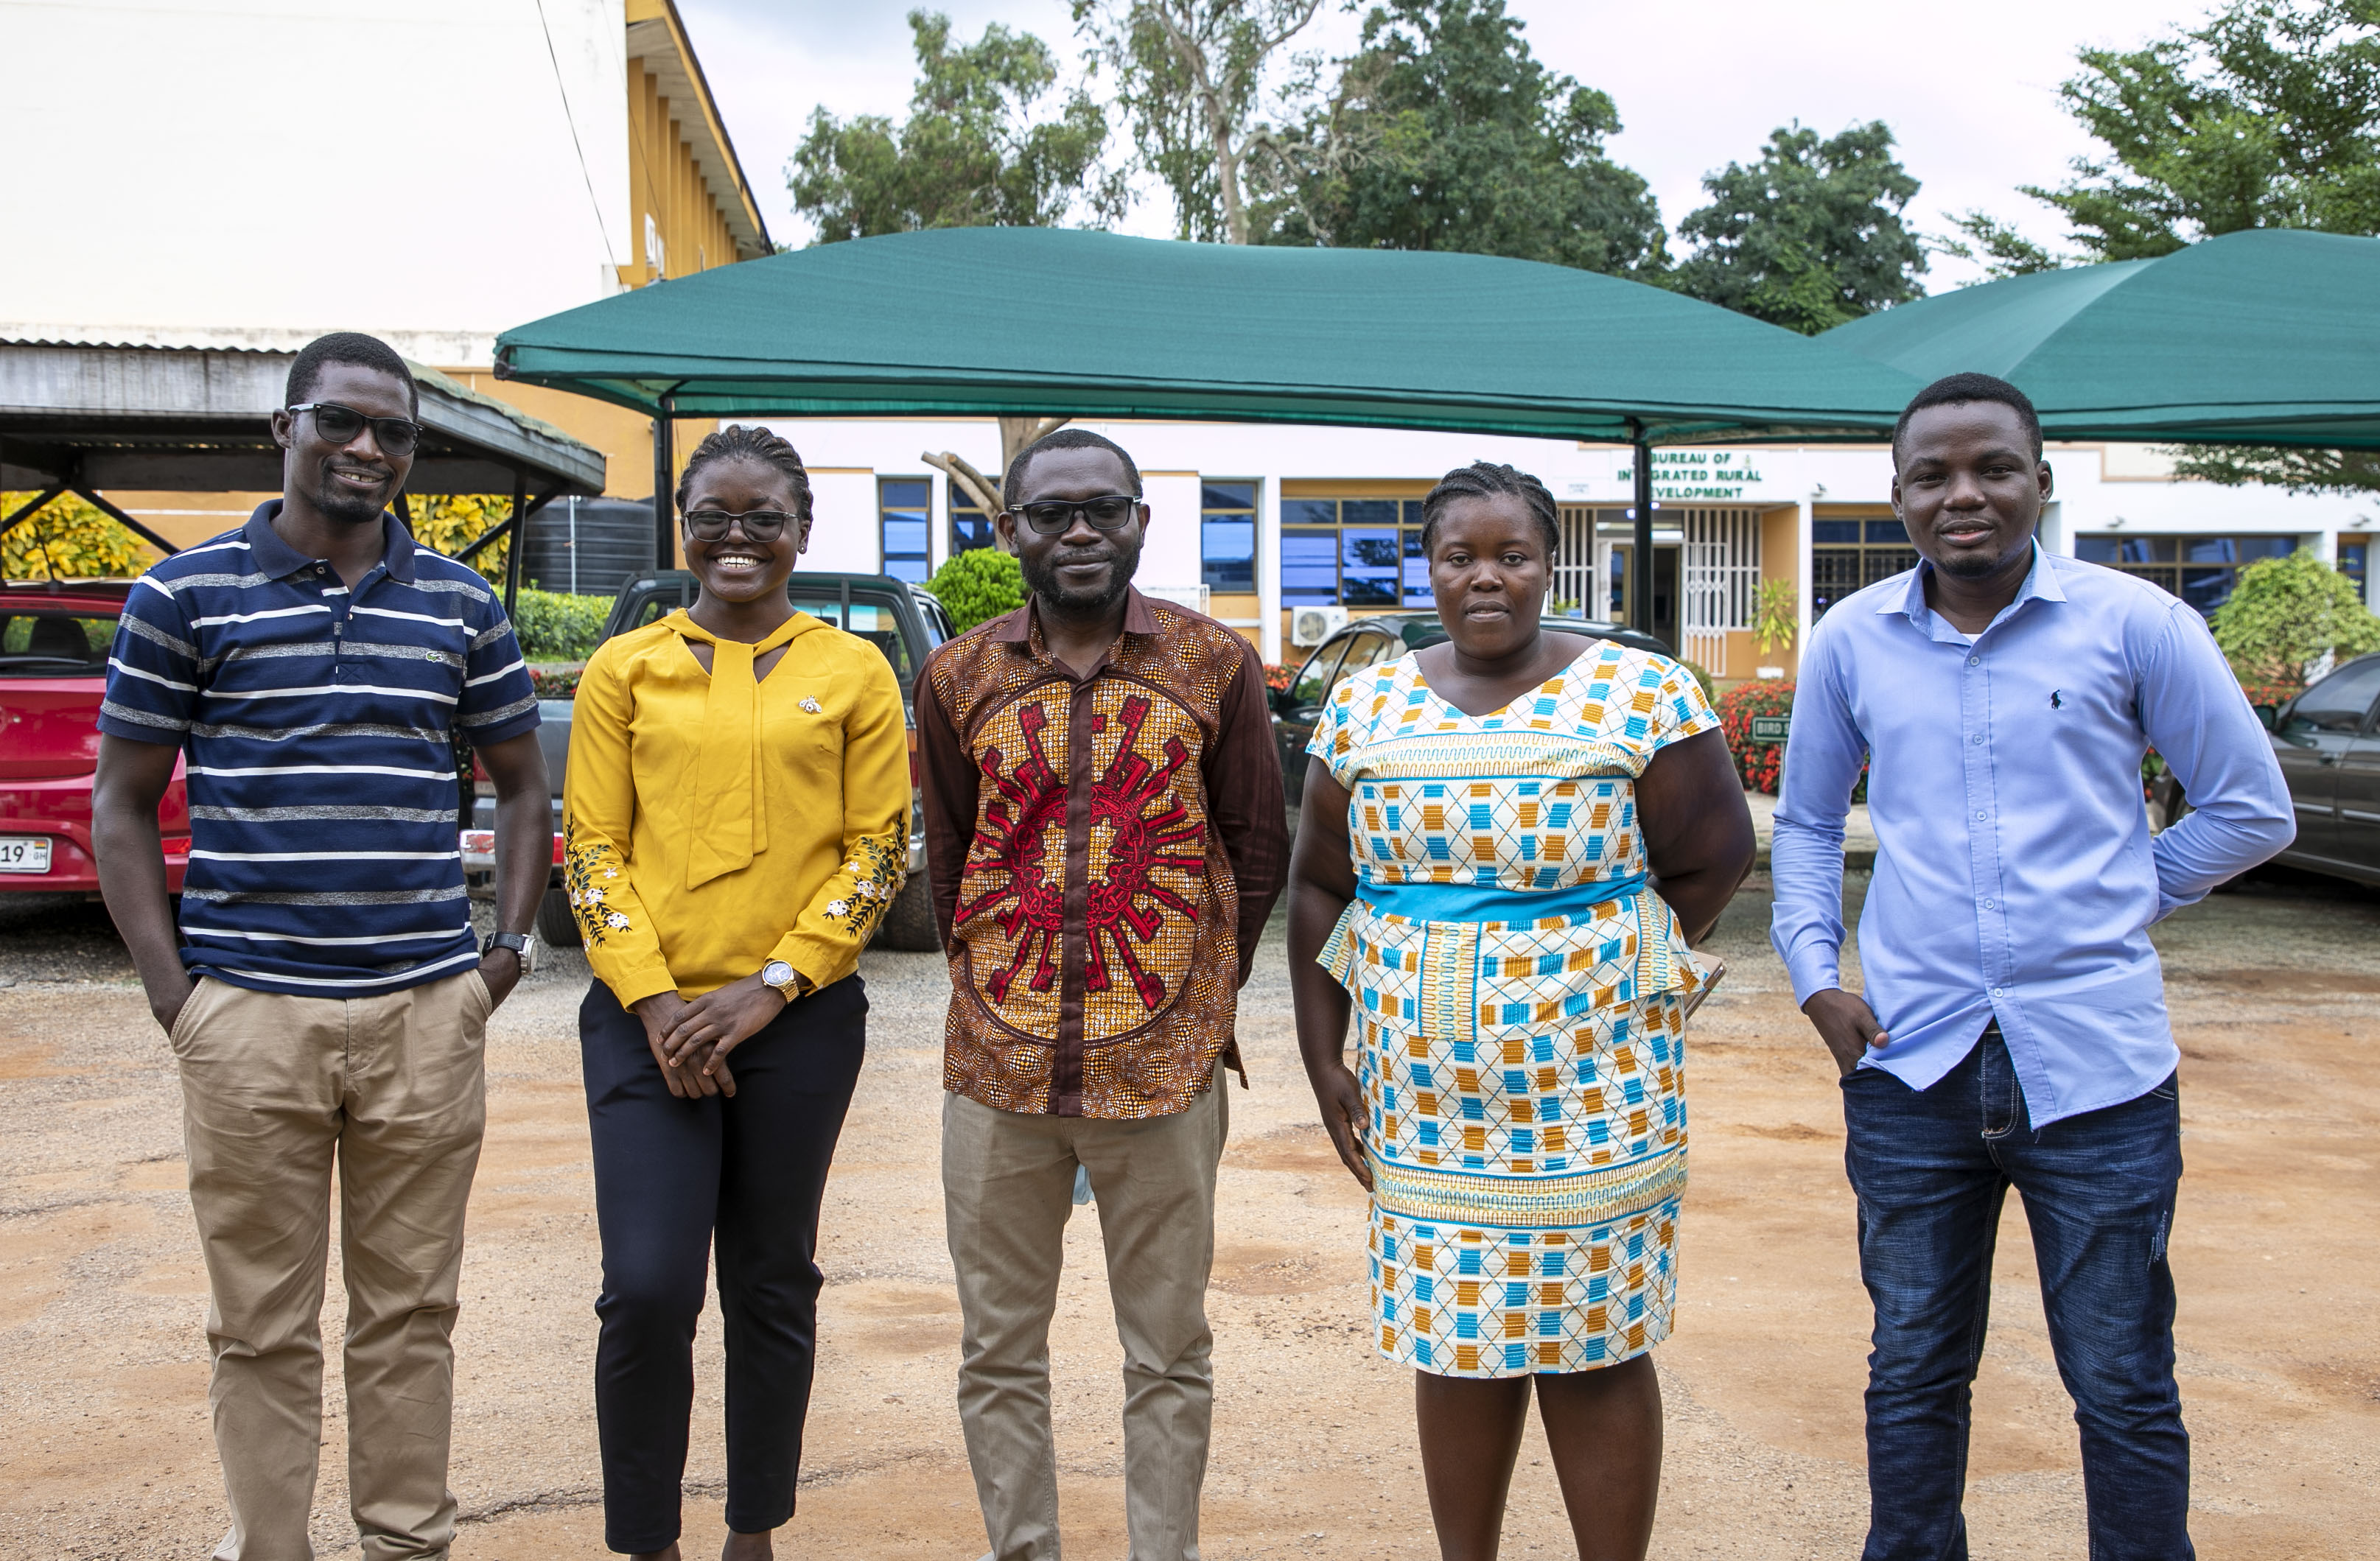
left=93, top=333, right=552, bottom=1561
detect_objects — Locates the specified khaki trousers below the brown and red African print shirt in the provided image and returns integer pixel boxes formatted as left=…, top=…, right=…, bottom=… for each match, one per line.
left=942, top=1081, right=1231, bottom=1561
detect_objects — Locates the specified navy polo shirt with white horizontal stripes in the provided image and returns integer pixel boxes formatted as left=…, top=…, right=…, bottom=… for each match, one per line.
left=100, top=499, right=538, bottom=997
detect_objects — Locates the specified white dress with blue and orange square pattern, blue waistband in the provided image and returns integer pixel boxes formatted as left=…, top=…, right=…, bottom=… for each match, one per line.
left=1306, top=640, right=1718, bottom=1378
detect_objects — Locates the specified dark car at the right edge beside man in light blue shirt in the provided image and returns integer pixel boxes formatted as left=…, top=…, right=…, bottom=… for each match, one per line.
left=2258, top=657, right=2380, bottom=885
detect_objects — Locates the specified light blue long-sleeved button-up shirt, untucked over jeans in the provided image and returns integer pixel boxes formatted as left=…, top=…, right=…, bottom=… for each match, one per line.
left=1771, top=550, right=2297, bottom=1128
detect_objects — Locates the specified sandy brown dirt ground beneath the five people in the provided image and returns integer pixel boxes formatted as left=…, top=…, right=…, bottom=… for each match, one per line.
left=0, top=876, right=2380, bottom=1561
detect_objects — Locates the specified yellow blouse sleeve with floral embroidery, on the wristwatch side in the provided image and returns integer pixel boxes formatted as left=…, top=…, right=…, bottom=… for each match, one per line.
left=776, top=657, right=909, bottom=988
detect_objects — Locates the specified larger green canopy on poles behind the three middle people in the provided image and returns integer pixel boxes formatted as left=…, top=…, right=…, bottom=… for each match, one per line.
left=495, top=228, right=1916, bottom=628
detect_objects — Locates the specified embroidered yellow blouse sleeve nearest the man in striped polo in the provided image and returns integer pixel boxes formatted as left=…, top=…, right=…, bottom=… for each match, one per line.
left=561, top=652, right=679, bottom=1006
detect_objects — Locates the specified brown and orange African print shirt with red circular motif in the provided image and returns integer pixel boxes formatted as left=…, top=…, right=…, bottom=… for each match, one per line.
left=917, top=590, right=1287, bottom=1118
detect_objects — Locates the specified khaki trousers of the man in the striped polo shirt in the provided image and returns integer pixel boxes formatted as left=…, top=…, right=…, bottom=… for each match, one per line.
left=169, top=971, right=490, bottom=1561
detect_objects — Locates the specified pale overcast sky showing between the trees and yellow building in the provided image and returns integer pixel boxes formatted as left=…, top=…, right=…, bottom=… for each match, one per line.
left=679, top=0, right=2204, bottom=290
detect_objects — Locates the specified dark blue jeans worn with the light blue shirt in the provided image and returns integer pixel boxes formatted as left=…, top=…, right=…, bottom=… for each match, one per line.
left=1842, top=1025, right=2194, bottom=1561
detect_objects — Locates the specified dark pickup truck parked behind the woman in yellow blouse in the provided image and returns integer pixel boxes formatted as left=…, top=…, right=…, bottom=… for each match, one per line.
left=462, top=569, right=950, bottom=952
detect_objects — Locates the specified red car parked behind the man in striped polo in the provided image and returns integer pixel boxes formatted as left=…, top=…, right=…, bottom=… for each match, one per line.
left=0, top=580, right=190, bottom=895
